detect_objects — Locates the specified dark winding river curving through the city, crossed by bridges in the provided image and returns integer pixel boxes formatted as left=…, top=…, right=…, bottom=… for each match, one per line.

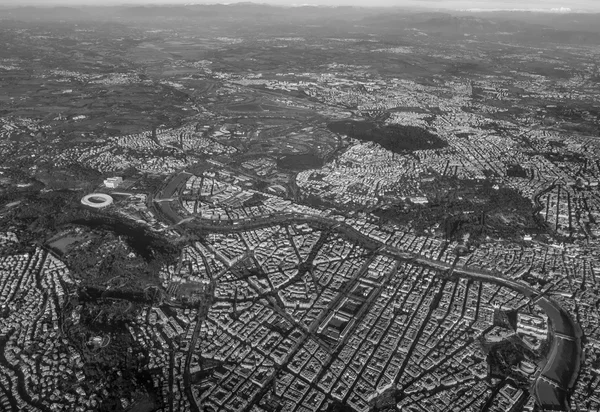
left=156, top=173, right=583, bottom=410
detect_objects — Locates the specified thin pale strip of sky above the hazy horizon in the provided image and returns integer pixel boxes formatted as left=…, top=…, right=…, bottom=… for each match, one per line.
left=0, top=0, right=600, bottom=12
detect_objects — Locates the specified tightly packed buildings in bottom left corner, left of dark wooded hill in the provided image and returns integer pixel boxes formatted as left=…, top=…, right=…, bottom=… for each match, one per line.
left=0, top=241, right=88, bottom=411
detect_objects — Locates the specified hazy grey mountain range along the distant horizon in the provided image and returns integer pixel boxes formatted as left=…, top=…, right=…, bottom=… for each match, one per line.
left=0, top=2, right=600, bottom=44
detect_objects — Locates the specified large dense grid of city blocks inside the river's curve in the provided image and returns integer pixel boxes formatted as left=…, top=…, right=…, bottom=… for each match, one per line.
left=150, top=224, right=547, bottom=411
